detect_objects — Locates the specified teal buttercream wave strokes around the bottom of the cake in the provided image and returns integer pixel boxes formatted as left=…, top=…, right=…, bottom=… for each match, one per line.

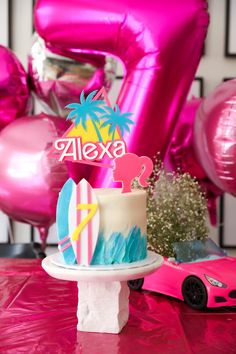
left=91, top=226, right=147, bottom=265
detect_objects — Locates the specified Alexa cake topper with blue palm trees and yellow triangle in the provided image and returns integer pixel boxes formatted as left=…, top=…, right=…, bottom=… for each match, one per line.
left=52, top=88, right=133, bottom=168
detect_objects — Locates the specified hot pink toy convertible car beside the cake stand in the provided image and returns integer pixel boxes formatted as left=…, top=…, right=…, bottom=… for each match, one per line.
left=129, top=239, right=236, bottom=310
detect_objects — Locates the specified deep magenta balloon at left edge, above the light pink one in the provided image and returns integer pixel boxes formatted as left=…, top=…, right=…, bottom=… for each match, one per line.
left=0, top=45, right=30, bottom=130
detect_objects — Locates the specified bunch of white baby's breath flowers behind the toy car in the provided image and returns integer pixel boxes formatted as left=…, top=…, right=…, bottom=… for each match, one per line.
left=134, top=155, right=208, bottom=257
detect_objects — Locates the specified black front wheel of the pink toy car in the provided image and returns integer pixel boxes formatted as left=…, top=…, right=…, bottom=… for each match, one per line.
left=182, top=277, right=207, bottom=310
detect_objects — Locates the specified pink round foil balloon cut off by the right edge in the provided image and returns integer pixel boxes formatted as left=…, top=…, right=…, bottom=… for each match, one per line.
left=194, top=80, right=236, bottom=195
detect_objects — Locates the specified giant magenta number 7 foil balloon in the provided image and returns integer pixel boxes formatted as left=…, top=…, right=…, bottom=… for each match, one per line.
left=35, top=0, right=208, bottom=186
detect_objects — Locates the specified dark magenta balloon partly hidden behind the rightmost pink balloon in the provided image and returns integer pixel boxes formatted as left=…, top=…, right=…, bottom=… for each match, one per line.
left=165, top=98, right=223, bottom=226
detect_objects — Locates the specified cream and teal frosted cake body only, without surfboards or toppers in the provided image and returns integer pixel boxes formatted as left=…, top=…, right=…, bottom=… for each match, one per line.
left=91, top=188, right=147, bottom=264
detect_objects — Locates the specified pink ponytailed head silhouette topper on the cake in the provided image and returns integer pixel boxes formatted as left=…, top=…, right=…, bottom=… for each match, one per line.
left=113, top=153, right=153, bottom=193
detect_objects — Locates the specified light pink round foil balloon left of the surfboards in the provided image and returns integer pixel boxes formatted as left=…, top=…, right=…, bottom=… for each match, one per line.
left=0, top=113, right=69, bottom=230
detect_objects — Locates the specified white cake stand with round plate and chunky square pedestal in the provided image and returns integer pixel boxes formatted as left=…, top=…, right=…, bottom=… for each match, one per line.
left=42, top=251, right=163, bottom=333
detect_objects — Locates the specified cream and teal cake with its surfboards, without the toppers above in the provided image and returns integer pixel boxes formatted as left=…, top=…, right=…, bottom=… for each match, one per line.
left=57, top=179, right=147, bottom=266
